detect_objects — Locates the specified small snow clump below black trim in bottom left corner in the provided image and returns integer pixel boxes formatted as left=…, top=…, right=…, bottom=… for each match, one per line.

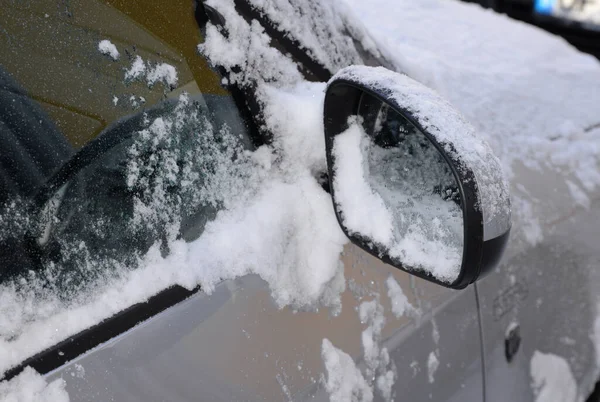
left=0, top=367, right=69, bottom=402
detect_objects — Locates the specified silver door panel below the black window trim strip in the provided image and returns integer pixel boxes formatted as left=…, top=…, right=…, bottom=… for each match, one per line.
left=48, top=246, right=483, bottom=401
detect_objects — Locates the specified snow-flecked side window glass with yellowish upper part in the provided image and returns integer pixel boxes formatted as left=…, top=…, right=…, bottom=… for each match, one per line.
left=0, top=0, right=252, bottom=286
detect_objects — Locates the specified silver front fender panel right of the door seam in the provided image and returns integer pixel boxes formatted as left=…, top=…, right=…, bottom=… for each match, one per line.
left=477, top=162, right=600, bottom=401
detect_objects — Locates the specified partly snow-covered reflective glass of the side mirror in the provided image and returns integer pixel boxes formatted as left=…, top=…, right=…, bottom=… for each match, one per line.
left=332, top=93, right=464, bottom=283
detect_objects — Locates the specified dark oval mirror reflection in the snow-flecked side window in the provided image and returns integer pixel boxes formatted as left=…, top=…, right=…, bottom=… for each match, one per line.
left=37, top=95, right=255, bottom=292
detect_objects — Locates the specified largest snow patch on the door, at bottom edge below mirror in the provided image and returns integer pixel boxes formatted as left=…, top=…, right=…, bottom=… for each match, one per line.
left=321, top=339, right=373, bottom=402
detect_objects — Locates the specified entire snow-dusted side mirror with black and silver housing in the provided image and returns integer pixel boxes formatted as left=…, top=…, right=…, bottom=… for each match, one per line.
left=324, top=66, right=511, bottom=289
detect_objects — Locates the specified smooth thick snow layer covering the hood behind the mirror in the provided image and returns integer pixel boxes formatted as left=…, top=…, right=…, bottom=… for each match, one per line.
left=344, top=0, right=600, bottom=251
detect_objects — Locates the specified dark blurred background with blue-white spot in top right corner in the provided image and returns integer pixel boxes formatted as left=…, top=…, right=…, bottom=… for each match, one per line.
left=463, top=0, right=600, bottom=59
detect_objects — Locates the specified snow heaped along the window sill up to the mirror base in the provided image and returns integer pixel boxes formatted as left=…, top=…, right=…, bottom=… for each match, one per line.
left=0, top=84, right=347, bottom=372
